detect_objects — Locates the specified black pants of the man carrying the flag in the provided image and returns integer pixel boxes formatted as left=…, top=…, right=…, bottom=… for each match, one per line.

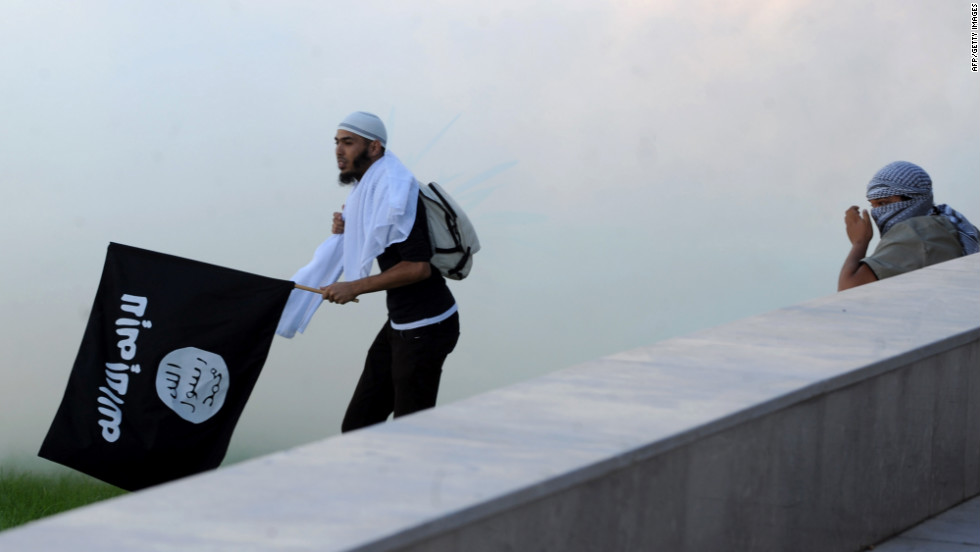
left=341, top=313, right=459, bottom=432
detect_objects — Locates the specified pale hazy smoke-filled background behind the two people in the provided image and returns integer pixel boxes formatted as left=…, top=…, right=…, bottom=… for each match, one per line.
left=0, top=0, right=980, bottom=467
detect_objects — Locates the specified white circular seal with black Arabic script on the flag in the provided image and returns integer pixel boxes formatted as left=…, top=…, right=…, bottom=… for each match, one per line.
left=157, top=347, right=228, bottom=424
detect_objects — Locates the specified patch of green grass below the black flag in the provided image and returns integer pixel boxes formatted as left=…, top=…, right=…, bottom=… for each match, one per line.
left=0, top=468, right=126, bottom=531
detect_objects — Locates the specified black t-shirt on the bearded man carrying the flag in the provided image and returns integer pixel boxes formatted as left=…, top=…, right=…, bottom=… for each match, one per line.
left=378, top=198, right=456, bottom=324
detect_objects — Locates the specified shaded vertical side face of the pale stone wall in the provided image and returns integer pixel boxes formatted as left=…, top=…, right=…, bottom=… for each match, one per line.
left=405, top=341, right=980, bottom=551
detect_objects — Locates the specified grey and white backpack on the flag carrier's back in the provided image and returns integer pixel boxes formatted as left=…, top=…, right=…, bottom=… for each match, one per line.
left=419, top=182, right=480, bottom=280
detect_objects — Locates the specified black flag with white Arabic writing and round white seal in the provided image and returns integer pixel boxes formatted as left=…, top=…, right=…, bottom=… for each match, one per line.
left=38, top=243, right=293, bottom=490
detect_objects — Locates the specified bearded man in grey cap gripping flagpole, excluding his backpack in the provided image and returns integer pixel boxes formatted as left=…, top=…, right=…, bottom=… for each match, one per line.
left=278, top=111, right=459, bottom=432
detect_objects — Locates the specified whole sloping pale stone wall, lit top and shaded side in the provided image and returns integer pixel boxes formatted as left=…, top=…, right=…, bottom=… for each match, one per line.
left=0, top=255, right=980, bottom=552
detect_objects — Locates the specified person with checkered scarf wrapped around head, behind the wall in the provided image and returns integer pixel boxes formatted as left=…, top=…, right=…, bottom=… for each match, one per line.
left=837, top=161, right=980, bottom=291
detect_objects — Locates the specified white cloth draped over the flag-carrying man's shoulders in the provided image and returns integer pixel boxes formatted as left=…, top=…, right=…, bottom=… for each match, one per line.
left=276, top=152, right=419, bottom=338
